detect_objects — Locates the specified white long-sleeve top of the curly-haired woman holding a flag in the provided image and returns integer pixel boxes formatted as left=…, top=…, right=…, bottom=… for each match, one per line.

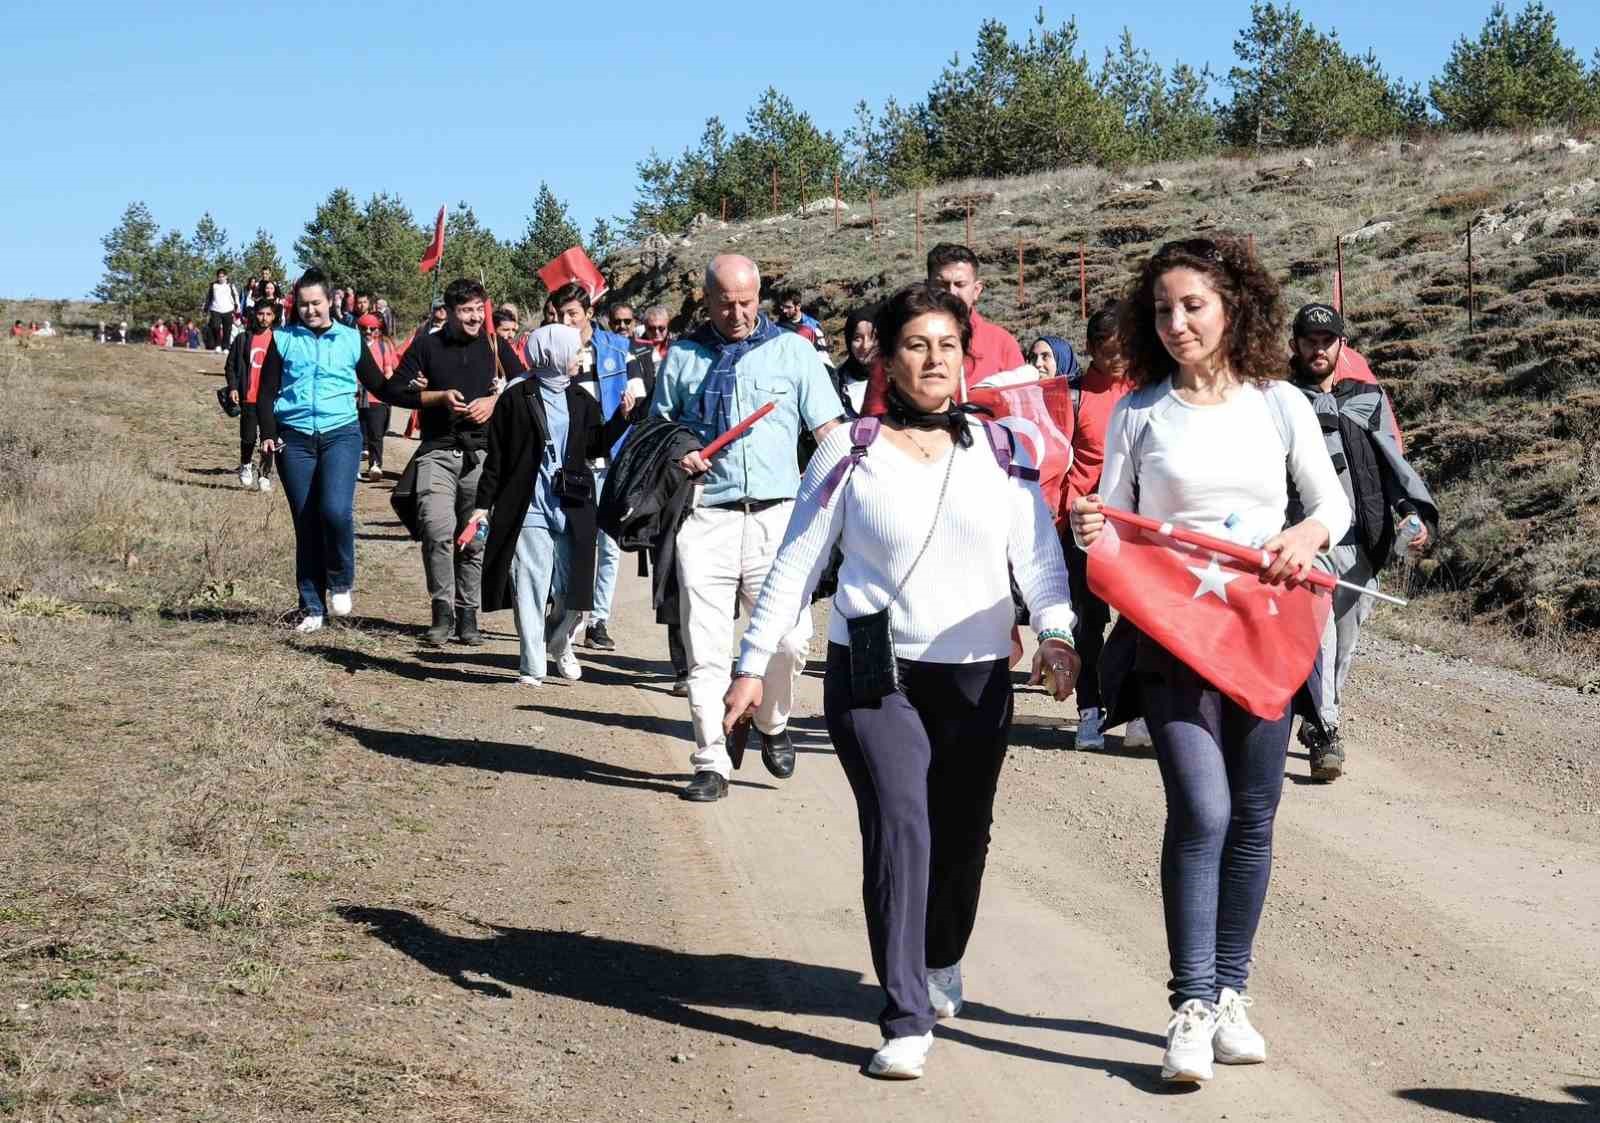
left=1099, top=379, right=1350, bottom=546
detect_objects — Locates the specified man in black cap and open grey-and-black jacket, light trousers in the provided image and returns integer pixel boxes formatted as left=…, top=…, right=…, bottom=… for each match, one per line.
left=1290, top=304, right=1438, bottom=782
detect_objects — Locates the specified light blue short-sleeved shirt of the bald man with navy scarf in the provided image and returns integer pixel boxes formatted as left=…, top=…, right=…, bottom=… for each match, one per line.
left=650, top=331, right=840, bottom=506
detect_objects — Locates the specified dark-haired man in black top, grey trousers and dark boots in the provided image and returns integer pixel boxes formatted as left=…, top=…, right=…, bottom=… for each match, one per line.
left=394, top=277, right=523, bottom=646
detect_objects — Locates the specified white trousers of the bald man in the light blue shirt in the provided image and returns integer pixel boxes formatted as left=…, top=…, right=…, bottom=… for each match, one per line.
left=677, top=502, right=811, bottom=779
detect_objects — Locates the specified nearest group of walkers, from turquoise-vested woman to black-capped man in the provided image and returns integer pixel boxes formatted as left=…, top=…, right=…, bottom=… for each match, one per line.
left=229, top=230, right=1438, bottom=1081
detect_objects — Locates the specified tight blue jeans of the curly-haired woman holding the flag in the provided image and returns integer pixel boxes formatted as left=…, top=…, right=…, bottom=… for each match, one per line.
left=1139, top=640, right=1294, bottom=1009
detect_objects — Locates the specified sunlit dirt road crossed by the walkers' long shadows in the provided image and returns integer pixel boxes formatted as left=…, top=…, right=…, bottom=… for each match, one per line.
left=330, top=442, right=1600, bottom=1121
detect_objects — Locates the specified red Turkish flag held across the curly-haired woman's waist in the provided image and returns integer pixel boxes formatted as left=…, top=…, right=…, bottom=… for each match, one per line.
left=1088, top=510, right=1333, bottom=721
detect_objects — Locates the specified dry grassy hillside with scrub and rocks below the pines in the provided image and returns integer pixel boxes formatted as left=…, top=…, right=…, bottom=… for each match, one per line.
left=608, top=134, right=1600, bottom=652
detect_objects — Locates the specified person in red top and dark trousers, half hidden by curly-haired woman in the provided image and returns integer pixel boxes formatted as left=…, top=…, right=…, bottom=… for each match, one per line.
left=1064, top=304, right=1150, bottom=749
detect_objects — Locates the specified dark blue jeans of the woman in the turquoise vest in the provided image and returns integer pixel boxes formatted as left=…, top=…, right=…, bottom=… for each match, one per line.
left=278, top=421, right=362, bottom=616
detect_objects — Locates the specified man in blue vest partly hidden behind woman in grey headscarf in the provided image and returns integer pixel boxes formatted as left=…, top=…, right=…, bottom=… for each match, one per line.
left=550, top=282, right=656, bottom=651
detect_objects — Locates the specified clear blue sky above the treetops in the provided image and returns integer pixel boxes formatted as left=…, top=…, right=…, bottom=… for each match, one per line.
left=0, top=0, right=1600, bottom=298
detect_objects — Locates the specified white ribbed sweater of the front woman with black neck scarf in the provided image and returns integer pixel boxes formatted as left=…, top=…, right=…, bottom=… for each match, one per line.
left=739, top=419, right=1074, bottom=673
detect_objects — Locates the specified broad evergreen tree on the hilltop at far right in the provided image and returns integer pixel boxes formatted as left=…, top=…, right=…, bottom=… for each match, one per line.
left=1429, top=0, right=1600, bottom=130
